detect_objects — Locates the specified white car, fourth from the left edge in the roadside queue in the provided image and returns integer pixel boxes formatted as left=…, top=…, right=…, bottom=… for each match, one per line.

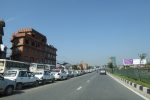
left=52, top=69, right=68, bottom=80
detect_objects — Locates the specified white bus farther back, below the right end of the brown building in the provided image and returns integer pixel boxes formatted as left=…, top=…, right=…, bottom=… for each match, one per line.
left=29, top=63, right=55, bottom=72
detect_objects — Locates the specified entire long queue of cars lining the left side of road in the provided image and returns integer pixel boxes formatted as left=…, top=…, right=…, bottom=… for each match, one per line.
left=0, top=69, right=95, bottom=95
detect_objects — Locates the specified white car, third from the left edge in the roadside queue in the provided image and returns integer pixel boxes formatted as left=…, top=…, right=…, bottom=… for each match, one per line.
left=34, top=70, right=55, bottom=84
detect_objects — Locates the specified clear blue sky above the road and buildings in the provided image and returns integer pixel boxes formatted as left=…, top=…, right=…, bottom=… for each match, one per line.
left=0, top=0, right=150, bottom=65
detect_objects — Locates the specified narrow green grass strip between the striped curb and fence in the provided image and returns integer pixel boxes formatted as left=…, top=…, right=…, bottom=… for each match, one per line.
left=113, top=74, right=150, bottom=88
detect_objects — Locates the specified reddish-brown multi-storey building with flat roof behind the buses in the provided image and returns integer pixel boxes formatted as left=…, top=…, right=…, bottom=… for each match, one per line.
left=11, top=28, right=57, bottom=65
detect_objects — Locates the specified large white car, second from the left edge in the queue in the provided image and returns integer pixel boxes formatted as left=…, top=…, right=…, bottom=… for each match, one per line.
left=4, top=69, right=39, bottom=90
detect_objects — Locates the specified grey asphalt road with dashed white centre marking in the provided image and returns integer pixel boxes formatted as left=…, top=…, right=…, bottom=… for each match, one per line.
left=0, top=72, right=143, bottom=100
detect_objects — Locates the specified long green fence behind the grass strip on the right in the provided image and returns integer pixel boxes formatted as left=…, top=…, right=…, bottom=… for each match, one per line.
left=109, top=68, right=150, bottom=84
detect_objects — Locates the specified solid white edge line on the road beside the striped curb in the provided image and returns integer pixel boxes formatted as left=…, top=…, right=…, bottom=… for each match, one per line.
left=108, top=74, right=149, bottom=100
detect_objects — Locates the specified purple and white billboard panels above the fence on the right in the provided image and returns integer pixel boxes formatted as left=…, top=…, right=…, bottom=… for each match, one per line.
left=123, top=59, right=147, bottom=65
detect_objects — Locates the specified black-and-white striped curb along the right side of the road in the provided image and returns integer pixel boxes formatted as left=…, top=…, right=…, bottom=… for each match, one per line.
left=108, top=73, right=150, bottom=100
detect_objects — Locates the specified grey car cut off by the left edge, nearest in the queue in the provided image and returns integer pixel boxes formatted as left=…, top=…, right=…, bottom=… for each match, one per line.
left=0, top=75, right=16, bottom=95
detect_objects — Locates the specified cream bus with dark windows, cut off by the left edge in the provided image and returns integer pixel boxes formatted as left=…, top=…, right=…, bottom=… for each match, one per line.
left=0, top=59, right=30, bottom=74
